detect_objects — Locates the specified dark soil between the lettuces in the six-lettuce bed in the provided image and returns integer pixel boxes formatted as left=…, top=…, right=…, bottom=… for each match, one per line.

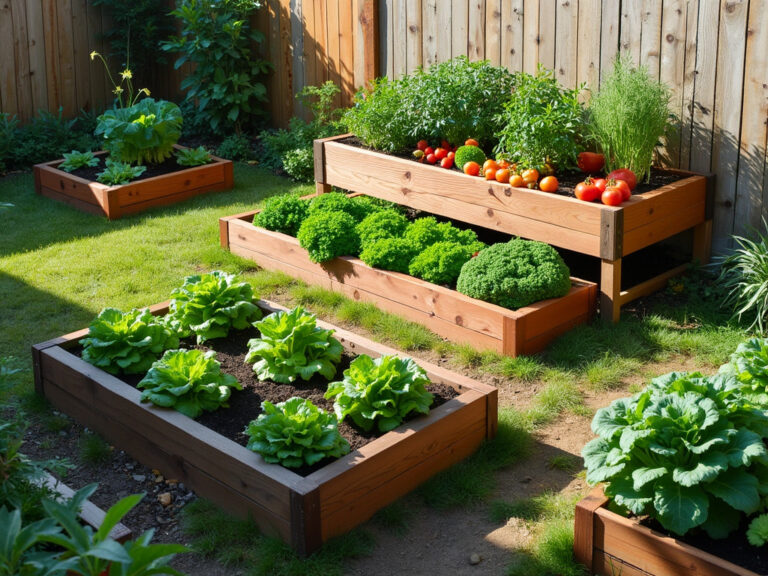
left=74, top=328, right=459, bottom=476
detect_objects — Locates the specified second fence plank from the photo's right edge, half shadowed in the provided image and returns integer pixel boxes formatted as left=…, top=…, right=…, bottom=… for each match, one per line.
left=712, top=0, right=749, bottom=252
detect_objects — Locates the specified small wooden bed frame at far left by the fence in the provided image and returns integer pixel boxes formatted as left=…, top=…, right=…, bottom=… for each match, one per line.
left=34, top=146, right=234, bottom=220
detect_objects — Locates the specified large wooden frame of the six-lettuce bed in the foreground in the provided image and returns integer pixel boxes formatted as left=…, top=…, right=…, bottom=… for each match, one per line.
left=32, top=301, right=497, bottom=554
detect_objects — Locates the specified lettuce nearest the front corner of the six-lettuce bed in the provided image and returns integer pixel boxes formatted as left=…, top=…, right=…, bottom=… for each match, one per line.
left=246, top=397, right=349, bottom=468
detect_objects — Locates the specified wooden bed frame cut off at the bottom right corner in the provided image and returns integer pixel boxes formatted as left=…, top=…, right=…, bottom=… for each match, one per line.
left=573, top=487, right=758, bottom=576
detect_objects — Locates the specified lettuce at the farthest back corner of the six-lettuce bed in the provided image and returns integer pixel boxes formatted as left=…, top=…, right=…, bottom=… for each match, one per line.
left=167, top=270, right=262, bottom=344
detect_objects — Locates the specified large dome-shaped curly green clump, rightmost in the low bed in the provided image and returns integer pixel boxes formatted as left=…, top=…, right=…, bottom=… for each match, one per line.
left=456, top=238, right=571, bottom=309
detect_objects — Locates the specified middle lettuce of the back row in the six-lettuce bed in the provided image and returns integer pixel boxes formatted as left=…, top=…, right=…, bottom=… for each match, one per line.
left=245, top=306, right=343, bottom=384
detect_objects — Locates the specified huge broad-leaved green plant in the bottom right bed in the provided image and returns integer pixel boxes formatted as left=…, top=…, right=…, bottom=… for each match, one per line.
left=582, top=373, right=768, bottom=538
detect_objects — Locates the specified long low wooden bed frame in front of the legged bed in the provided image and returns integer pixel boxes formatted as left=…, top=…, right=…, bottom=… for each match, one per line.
left=219, top=205, right=597, bottom=356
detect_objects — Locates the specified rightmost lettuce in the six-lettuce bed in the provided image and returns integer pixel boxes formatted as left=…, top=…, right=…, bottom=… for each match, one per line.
left=325, top=354, right=433, bottom=432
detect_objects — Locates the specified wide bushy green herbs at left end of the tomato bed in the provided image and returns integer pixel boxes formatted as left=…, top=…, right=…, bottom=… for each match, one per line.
left=344, top=56, right=515, bottom=152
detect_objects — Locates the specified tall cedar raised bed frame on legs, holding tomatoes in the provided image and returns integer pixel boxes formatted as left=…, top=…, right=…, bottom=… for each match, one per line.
left=314, top=134, right=714, bottom=322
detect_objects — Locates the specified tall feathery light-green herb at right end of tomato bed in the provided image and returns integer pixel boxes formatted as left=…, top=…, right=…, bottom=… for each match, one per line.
left=588, top=56, right=672, bottom=182
